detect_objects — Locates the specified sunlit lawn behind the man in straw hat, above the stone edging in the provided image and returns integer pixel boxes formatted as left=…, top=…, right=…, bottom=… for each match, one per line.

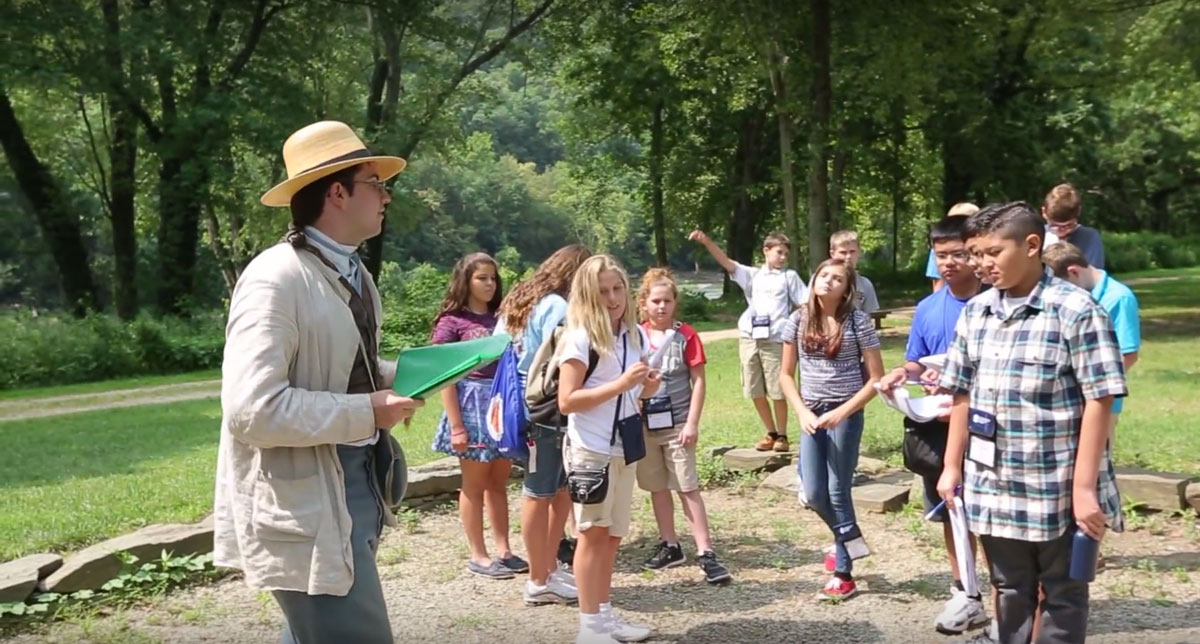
left=0, top=399, right=442, bottom=561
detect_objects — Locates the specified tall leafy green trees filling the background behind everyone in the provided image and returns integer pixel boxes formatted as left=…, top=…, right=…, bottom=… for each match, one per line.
left=0, top=0, right=1200, bottom=337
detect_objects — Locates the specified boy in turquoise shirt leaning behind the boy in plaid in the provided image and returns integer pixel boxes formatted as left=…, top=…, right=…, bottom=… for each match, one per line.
left=1042, top=241, right=1141, bottom=443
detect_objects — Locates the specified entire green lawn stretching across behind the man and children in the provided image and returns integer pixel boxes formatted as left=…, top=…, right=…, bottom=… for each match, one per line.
left=0, top=269, right=1200, bottom=560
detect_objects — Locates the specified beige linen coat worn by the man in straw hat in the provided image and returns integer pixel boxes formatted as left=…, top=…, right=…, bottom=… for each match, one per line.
left=214, top=243, right=396, bottom=596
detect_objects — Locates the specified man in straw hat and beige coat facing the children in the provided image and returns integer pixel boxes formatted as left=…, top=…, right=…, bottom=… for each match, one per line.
left=214, top=121, right=422, bottom=644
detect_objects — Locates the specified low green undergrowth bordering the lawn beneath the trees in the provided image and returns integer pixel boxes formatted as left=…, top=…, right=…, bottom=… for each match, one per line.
left=0, top=233, right=1200, bottom=390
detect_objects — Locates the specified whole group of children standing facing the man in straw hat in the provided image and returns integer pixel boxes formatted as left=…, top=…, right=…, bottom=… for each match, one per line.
left=433, top=186, right=1140, bottom=644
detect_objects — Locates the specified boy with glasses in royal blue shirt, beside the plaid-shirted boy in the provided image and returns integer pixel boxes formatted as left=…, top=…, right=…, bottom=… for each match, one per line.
left=880, top=210, right=988, bottom=634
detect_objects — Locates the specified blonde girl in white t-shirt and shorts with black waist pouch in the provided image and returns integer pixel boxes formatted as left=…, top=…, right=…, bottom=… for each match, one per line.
left=558, top=255, right=660, bottom=644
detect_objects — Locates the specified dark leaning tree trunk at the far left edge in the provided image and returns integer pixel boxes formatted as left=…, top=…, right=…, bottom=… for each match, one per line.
left=0, top=85, right=100, bottom=317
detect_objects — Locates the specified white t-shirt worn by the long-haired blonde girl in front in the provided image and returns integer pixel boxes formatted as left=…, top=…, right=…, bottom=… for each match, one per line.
left=559, top=325, right=650, bottom=458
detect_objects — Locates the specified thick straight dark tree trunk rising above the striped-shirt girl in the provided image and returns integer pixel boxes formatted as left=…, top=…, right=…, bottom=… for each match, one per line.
left=809, top=0, right=833, bottom=269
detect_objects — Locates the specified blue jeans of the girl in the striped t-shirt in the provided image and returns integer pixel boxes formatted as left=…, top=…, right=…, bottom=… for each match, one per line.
left=797, top=404, right=863, bottom=574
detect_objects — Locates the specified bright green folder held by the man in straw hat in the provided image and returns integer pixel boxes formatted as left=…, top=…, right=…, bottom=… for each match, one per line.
left=391, top=333, right=512, bottom=399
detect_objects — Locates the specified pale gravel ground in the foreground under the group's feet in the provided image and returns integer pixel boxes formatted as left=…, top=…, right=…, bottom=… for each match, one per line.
left=11, top=487, right=1200, bottom=644
